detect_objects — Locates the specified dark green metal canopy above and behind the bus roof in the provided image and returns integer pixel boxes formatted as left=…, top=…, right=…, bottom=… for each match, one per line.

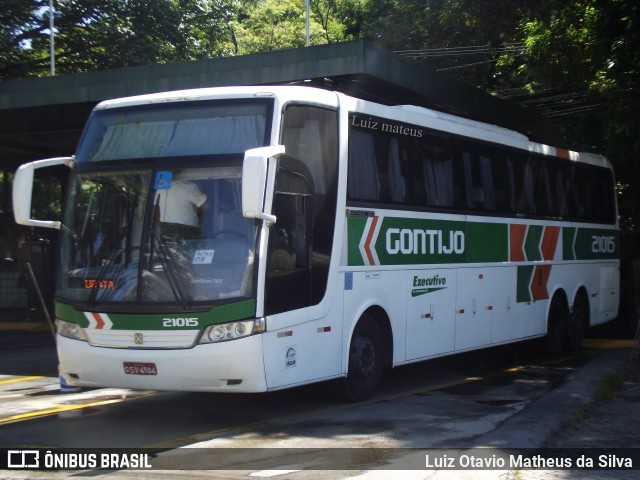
left=0, top=41, right=554, bottom=169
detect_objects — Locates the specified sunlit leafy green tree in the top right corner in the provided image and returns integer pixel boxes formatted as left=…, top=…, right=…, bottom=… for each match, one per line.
left=517, top=0, right=640, bottom=217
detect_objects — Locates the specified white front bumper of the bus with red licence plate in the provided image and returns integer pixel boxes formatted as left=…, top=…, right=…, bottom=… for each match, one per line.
left=58, top=335, right=267, bottom=392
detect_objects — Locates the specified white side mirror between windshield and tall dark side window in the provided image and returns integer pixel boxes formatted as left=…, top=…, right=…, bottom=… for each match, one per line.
left=242, top=145, right=284, bottom=223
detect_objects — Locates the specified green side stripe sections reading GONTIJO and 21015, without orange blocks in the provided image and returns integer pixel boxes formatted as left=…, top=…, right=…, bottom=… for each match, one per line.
left=347, top=216, right=620, bottom=267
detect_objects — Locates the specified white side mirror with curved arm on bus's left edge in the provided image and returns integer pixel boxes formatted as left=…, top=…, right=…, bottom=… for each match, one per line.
left=12, top=157, right=75, bottom=230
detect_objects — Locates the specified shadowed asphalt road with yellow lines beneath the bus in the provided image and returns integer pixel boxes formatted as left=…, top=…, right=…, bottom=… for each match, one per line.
left=0, top=328, right=632, bottom=480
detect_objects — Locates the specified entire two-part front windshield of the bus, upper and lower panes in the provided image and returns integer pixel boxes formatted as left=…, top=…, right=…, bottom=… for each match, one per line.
left=57, top=99, right=272, bottom=310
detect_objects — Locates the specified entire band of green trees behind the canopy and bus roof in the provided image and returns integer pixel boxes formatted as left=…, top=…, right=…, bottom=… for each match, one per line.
left=0, top=0, right=640, bottom=219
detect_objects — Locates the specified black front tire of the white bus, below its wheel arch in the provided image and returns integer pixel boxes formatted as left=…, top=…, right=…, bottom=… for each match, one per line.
left=340, top=313, right=383, bottom=402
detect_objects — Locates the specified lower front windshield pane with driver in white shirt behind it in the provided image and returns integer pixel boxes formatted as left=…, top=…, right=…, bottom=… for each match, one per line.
left=58, top=166, right=257, bottom=308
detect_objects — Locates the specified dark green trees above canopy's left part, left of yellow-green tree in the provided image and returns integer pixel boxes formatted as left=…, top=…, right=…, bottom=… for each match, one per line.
left=0, top=0, right=238, bottom=78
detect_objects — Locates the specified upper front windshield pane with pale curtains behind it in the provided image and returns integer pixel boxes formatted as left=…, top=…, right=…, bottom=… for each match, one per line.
left=76, top=99, right=272, bottom=166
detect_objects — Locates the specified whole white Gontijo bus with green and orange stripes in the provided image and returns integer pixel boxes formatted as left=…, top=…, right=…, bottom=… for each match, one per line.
left=14, top=86, right=620, bottom=400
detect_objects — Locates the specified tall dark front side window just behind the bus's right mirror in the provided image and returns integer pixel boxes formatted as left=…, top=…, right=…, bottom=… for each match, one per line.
left=265, top=104, right=338, bottom=314
